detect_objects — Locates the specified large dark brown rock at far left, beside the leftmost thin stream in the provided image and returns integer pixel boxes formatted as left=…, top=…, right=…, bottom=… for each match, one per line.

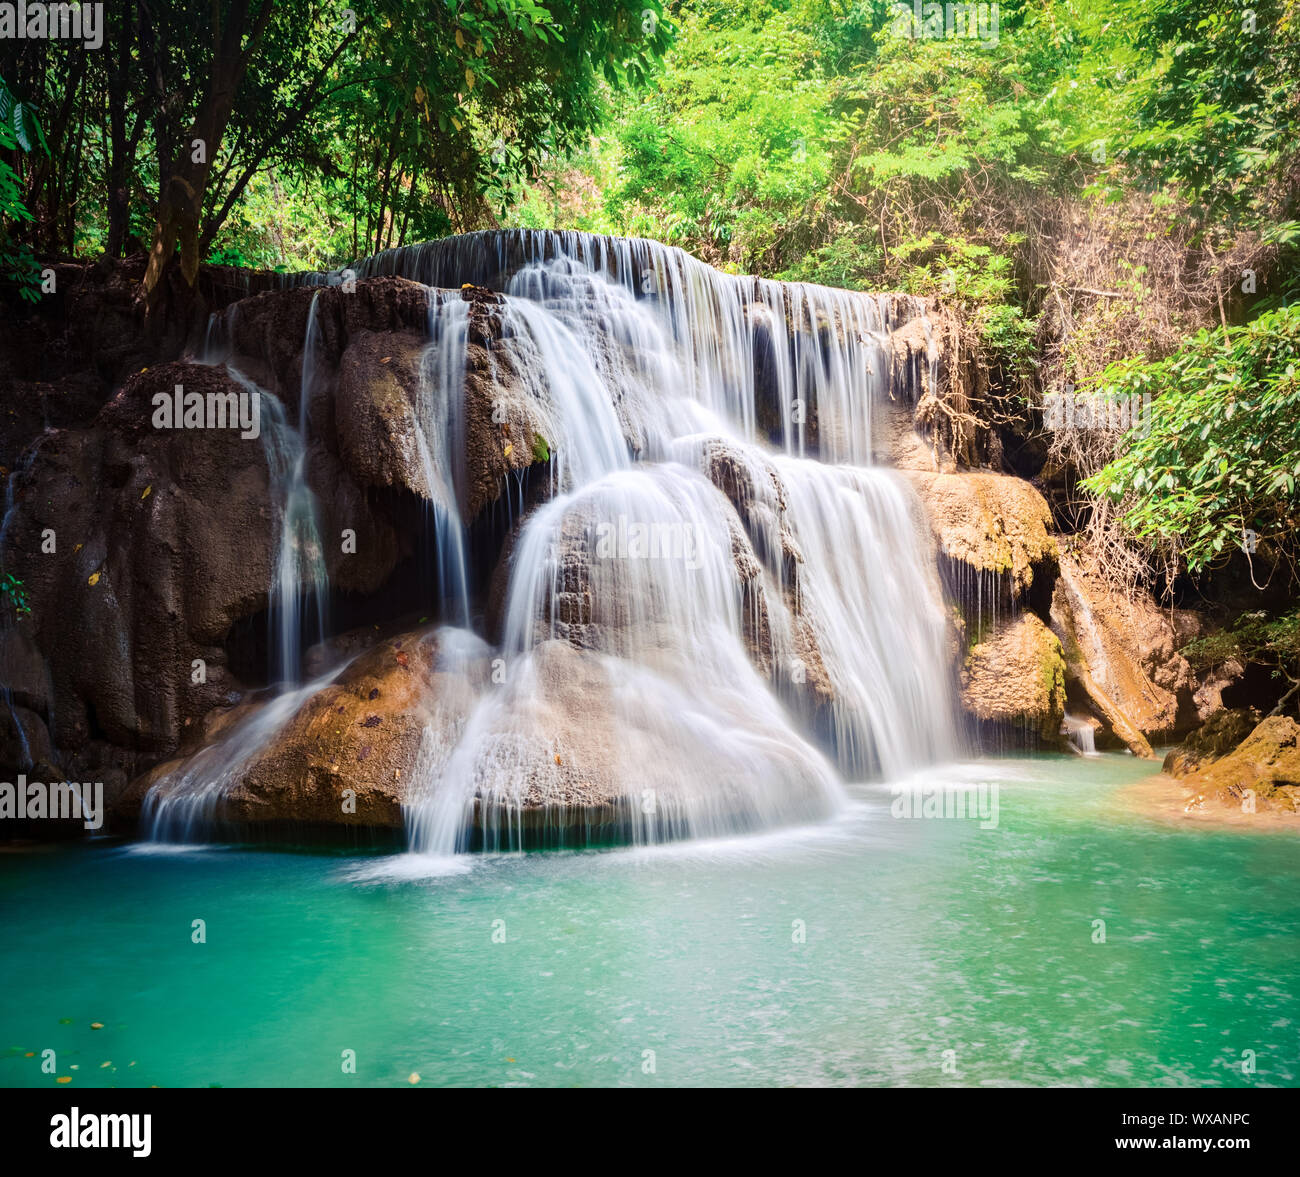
left=5, top=363, right=272, bottom=757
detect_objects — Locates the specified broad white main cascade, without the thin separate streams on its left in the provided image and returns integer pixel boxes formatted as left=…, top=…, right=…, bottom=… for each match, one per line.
left=384, top=234, right=957, bottom=856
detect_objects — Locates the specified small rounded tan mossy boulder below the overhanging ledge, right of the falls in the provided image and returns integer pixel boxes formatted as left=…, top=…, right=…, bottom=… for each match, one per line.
left=961, top=613, right=1065, bottom=747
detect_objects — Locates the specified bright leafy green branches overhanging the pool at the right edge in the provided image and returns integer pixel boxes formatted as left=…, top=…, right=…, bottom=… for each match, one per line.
left=1086, top=307, right=1300, bottom=571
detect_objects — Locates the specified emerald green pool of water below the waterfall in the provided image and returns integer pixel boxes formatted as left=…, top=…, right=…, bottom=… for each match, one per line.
left=0, top=757, right=1300, bottom=1090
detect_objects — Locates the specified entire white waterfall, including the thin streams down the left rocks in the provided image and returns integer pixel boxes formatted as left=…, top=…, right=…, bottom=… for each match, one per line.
left=147, top=231, right=959, bottom=856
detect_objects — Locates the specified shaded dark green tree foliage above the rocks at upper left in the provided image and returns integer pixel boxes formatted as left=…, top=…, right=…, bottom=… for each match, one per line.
left=10, top=0, right=672, bottom=268
